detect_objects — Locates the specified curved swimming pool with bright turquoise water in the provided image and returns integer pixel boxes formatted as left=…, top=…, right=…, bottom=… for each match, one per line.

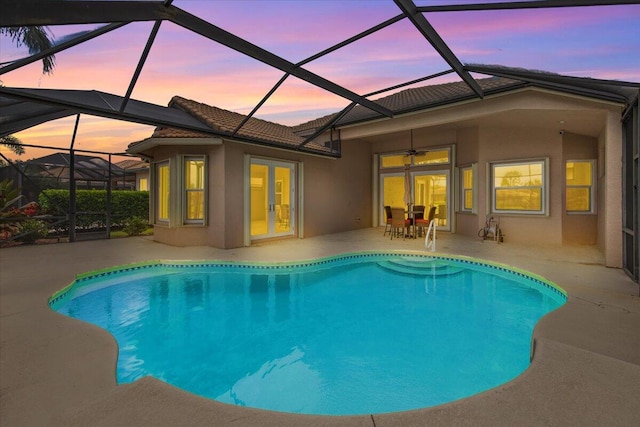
left=50, top=252, right=566, bottom=415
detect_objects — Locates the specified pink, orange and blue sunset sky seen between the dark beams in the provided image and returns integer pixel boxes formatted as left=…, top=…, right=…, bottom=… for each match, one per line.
left=0, top=0, right=640, bottom=159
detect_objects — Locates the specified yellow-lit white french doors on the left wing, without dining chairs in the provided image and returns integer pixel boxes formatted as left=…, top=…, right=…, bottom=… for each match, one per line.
left=250, top=159, right=296, bottom=240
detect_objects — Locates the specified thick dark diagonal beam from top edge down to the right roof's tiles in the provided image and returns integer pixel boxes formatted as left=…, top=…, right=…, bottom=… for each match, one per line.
left=394, top=0, right=484, bottom=98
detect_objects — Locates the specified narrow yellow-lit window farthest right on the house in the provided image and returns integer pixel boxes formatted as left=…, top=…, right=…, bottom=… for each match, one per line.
left=565, top=160, right=595, bottom=213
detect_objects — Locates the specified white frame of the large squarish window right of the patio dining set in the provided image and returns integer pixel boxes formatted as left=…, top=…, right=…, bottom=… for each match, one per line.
left=487, top=157, right=549, bottom=216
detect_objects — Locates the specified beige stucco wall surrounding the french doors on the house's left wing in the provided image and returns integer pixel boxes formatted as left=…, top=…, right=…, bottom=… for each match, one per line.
left=153, top=142, right=372, bottom=248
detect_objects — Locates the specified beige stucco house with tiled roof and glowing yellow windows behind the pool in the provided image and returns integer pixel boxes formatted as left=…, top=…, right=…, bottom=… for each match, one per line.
left=128, top=73, right=638, bottom=276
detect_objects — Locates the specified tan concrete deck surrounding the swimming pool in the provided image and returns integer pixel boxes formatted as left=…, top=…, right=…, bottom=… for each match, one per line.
left=0, top=228, right=640, bottom=427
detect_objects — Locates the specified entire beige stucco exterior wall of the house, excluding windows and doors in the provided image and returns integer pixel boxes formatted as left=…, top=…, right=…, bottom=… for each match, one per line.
left=140, top=87, right=622, bottom=266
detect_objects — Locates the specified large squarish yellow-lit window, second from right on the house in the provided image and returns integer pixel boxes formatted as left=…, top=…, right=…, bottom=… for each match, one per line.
left=491, top=160, right=547, bottom=214
